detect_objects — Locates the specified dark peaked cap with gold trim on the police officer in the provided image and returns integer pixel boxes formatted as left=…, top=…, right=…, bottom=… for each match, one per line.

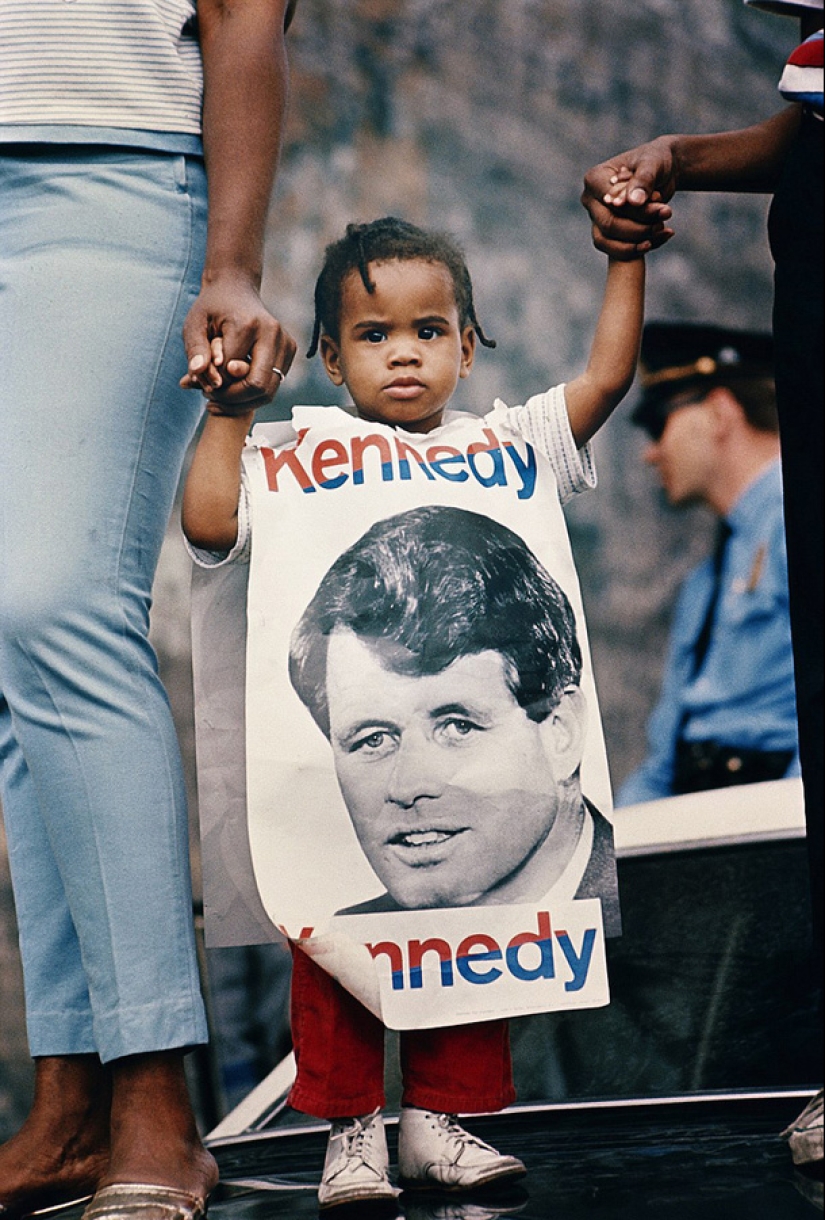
left=631, top=322, right=774, bottom=438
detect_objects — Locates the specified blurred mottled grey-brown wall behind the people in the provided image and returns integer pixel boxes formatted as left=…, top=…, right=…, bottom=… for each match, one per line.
left=0, top=0, right=796, bottom=1138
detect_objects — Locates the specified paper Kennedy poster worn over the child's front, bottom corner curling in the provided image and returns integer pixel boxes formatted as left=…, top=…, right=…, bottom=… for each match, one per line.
left=195, top=392, right=619, bottom=1028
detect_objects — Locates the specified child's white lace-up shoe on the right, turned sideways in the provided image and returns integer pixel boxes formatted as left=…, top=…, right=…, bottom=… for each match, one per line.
left=398, top=1110, right=527, bottom=1191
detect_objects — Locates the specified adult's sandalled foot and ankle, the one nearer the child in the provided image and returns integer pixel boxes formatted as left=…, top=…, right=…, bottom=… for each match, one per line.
left=100, top=1052, right=218, bottom=1200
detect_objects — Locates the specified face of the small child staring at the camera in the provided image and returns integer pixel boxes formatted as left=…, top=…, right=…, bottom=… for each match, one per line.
left=321, top=260, right=476, bottom=432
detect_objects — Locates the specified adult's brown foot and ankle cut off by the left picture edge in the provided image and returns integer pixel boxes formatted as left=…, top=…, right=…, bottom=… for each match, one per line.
left=0, top=1055, right=110, bottom=1220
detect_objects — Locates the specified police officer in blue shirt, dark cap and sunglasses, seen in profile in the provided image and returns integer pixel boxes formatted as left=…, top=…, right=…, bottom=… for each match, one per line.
left=616, top=322, right=798, bottom=805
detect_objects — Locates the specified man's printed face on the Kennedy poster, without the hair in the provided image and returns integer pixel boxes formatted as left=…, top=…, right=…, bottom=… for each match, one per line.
left=327, top=628, right=582, bottom=909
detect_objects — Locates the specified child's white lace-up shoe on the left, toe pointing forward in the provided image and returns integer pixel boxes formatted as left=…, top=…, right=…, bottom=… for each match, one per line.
left=319, top=1110, right=400, bottom=1210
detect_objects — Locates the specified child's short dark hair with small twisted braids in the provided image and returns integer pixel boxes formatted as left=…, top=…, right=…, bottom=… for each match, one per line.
left=306, top=216, right=495, bottom=359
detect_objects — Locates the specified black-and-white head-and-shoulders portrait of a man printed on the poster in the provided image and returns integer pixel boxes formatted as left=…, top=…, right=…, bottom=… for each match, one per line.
left=289, top=506, right=616, bottom=924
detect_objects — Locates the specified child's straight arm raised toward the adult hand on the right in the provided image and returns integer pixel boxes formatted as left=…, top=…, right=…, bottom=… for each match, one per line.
left=565, top=259, right=644, bottom=448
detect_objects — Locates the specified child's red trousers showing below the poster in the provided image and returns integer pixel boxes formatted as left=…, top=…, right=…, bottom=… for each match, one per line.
left=289, top=949, right=515, bottom=1120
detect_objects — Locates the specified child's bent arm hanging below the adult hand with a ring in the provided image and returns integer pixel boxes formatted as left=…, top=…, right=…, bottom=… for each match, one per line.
left=182, top=411, right=255, bottom=550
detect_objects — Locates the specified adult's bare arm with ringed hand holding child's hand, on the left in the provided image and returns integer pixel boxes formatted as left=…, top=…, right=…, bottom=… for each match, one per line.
left=183, top=0, right=295, bottom=410
